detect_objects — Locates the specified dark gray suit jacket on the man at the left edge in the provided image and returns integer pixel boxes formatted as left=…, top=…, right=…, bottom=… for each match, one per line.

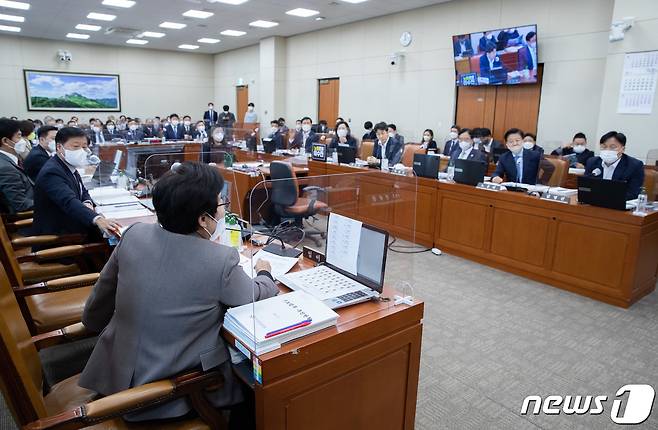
left=0, top=153, right=34, bottom=213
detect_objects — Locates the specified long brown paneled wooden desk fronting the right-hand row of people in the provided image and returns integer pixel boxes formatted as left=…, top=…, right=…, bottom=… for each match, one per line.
left=309, top=161, right=658, bottom=307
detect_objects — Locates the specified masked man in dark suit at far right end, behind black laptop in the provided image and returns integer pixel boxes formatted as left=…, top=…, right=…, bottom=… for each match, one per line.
left=585, top=131, right=644, bottom=200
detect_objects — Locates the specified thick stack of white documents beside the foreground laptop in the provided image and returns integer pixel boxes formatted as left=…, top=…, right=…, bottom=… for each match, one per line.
left=224, top=291, right=338, bottom=355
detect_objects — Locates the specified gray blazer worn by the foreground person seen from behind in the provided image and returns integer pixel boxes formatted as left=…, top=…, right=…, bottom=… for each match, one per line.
left=79, top=224, right=278, bottom=421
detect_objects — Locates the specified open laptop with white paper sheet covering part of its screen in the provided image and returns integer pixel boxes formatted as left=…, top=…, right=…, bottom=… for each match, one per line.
left=278, top=213, right=388, bottom=309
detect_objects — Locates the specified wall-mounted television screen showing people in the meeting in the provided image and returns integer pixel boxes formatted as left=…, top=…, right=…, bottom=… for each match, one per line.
left=452, top=25, right=537, bottom=86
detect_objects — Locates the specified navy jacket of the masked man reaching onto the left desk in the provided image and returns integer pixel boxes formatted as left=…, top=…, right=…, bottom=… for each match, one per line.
left=33, top=155, right=98, bottom=239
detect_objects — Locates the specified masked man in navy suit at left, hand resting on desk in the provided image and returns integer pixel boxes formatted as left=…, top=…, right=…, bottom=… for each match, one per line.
left=33, top=127, right=121, bottom=241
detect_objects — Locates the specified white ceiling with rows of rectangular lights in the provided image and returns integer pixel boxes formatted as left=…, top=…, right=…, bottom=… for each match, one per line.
left=6, top=0, right=449, bottom=54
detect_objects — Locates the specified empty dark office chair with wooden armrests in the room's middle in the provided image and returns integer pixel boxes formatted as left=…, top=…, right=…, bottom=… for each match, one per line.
left=270, top=161, right=328, bottom=239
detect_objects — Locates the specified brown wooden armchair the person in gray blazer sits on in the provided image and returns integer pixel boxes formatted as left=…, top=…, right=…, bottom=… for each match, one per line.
left=0, top=268, right=226, bottom=430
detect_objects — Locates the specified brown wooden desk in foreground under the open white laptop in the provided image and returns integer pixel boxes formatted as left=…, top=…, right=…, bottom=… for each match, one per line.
left=116, top=210, right=424, bottom=430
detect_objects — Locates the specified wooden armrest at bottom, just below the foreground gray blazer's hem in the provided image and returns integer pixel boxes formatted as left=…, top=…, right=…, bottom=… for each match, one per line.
left=23, top=371, right=225, bottom=430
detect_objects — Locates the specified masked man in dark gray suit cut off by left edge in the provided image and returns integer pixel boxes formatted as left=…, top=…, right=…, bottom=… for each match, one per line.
left=0, top=118, right=34, bottom=213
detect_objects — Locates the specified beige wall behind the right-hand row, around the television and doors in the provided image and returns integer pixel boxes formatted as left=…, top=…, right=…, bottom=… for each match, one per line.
left=215, top=0, right=613, bottom=154
